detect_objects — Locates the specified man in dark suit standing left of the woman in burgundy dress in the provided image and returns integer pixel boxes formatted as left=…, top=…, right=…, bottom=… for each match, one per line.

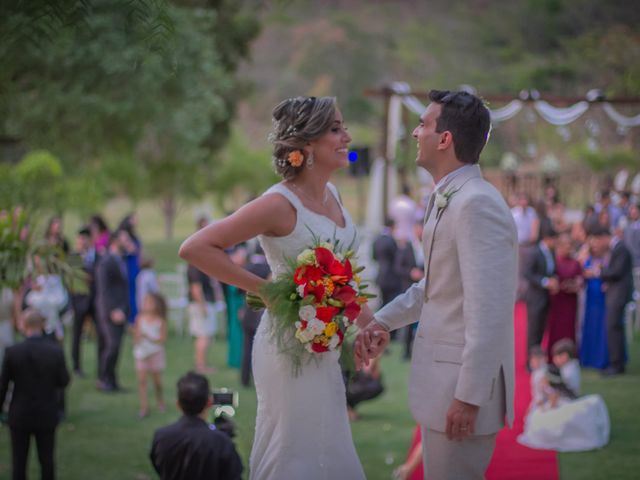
left=522, top=227, right=558, bottom=352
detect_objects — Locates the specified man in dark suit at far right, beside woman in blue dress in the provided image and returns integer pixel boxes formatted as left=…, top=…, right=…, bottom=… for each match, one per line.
left=593, top=227, right=633, bottom=376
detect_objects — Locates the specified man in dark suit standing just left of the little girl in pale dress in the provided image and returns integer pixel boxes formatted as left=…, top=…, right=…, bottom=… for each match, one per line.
left=96, top=230, right=129, bottom=392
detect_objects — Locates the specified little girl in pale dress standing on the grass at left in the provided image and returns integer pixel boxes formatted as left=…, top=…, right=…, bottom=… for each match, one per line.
left=133, top=292, right=167, bottom=418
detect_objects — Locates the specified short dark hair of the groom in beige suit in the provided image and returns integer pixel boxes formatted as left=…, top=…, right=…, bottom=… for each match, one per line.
left=429, top=90, right=491, bottom=164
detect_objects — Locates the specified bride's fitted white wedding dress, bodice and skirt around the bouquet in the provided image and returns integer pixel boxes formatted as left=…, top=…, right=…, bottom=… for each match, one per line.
left=249, top=184, right=365, bottom=480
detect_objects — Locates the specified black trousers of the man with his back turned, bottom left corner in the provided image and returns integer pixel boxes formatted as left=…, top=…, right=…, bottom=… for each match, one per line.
left=10, top=427, right=56, bottom=480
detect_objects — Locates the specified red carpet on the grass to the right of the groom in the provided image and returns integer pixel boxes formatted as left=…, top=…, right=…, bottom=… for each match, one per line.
left=487, top=303, right=559, bottom=480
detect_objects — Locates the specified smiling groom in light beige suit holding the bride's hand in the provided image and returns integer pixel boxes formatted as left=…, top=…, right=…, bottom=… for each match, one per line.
left=356, top=90, right=518, bottom=480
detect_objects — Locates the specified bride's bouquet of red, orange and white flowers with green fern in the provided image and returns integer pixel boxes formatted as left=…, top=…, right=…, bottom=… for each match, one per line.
left=248, top=235, right=375, bottom=366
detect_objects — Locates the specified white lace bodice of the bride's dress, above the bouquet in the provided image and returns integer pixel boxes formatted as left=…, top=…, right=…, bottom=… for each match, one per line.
left=258, top=183, right=358, bottom=277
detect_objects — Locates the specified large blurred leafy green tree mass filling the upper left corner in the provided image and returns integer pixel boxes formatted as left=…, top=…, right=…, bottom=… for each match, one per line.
left=0, top=0, right=258, bottom=236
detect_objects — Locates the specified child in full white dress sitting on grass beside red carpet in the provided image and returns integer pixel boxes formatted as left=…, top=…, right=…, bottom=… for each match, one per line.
left=518, top=339, right=610, bottom=452
